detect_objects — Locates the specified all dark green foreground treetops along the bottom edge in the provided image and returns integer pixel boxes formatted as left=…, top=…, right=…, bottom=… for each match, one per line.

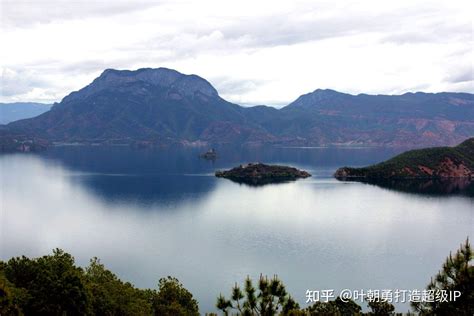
left=0, top=240, right=474, bottom=316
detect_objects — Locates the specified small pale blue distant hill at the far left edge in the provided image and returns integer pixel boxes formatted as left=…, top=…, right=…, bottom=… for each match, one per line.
left=0, top=102, right=52, bottom=124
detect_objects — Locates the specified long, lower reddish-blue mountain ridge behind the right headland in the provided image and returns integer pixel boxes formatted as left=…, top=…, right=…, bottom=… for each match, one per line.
left=270, top=90, right=474, bottom=147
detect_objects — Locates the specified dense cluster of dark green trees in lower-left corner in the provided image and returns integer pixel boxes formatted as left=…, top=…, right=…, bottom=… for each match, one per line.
left=0, top=249, right=199, bottom=316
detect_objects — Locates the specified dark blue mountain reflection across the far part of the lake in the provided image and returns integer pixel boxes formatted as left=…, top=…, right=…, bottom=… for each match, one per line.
left=32, top=146, right=404, bottom=205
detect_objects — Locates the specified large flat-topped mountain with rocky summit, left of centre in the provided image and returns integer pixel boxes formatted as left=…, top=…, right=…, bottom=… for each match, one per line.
left=8, top=68, right=270, bottom=143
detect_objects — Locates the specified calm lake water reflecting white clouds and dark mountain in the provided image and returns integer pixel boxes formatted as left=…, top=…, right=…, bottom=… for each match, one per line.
left=0, top=147, right=474, bottom=313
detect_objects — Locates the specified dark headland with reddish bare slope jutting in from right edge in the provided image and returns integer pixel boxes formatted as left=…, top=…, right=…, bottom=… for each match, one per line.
left=335, top=138, right=474, bottom=179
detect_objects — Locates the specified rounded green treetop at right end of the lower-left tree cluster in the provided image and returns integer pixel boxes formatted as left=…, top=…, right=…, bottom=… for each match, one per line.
left=152, top=276, right=199, bottom=316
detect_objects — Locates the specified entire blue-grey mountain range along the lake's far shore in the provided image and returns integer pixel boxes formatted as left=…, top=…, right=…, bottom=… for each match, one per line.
left=0, top=68, right=474, bottom=147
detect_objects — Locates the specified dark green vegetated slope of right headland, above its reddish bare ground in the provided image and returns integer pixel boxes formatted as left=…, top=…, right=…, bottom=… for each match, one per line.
left=338, top=138, right=474, bottom=178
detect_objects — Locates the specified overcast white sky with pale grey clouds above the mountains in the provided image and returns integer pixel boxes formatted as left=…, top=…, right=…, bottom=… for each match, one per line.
left=0, top=0, right=474, bottom=107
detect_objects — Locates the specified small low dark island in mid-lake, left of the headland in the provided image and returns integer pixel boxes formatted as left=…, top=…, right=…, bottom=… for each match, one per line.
left=216, top=163, right=311, bottom=185
